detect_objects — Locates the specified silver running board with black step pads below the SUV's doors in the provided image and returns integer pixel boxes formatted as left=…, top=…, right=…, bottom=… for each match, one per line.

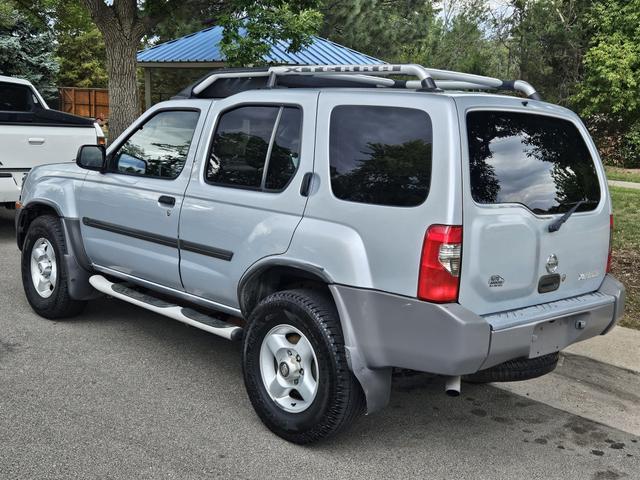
left=89, top=275, right=243, bottom=340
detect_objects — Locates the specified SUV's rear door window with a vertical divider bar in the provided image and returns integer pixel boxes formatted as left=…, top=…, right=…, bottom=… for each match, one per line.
left=206, top=106, right=302, bottom=191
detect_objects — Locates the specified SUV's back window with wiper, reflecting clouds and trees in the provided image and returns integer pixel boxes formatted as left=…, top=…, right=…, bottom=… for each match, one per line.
left=467, top=111, right=600, bottom=214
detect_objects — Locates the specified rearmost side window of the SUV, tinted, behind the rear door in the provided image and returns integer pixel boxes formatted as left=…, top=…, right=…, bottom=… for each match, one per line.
left=329, top=105, right=433, bottom=207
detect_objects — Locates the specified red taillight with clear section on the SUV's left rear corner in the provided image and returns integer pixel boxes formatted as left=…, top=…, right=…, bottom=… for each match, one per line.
left=418, top=225, right=462, bottom=303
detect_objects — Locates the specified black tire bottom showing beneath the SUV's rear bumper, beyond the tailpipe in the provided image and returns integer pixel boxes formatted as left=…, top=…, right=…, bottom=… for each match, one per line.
left=463, top=352, right=560, bottom=383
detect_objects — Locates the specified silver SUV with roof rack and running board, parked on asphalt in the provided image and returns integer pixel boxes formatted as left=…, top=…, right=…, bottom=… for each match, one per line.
left=17, top=65, right=624, bottom=443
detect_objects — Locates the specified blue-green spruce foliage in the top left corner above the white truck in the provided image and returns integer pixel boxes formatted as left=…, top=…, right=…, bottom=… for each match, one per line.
left=0, top=3, right=58, bottom=98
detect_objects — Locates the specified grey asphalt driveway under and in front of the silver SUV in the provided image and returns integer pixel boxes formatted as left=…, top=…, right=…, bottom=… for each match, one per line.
left=0, top=211, right=640, bottom=480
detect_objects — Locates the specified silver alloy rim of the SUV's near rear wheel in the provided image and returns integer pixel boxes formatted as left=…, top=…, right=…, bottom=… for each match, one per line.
left=260, top=322, right=319, bottom=413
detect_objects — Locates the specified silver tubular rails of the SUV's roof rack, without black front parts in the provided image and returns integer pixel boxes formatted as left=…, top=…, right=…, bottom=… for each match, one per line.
left=193, top=64, right=542, bottom=100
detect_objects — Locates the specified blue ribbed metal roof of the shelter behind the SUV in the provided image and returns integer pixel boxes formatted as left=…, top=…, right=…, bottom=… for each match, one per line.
left=138, top=27, right=385, bottom=65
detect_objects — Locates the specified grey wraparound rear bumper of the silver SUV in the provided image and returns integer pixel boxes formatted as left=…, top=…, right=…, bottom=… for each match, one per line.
left=331, top=275, right=624, bottom=404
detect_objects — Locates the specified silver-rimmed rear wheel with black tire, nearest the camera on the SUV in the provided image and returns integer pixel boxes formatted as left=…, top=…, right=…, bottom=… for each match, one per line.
left=242, top=290, right=364, bottom=444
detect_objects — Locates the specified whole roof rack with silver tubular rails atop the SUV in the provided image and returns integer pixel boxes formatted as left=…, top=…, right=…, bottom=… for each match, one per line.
left=189, top=64, right=542, bottom=100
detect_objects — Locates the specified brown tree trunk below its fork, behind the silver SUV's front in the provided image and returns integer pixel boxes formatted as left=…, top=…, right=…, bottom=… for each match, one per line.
left=103, top=32, right=140, bottom=142
